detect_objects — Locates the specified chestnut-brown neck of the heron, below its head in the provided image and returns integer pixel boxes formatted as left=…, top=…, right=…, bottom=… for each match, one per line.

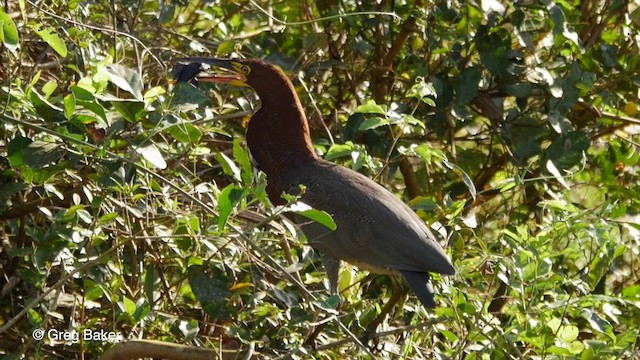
left=247, top=90, right=317, bottom=177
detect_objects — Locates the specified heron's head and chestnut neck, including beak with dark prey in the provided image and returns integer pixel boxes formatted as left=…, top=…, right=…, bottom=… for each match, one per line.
left=173, top=57, right=316, bottom=172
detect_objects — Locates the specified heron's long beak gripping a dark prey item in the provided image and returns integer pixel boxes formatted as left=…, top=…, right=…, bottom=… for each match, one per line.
left=171, top=57, right=247, bottom=86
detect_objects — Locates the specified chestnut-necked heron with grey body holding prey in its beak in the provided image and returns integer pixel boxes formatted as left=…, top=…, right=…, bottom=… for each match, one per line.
left=173, top=57, right=455, bottom=309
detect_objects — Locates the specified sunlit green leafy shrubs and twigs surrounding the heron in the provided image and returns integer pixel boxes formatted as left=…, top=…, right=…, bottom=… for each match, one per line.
left=0, top=0, right=640, bottom=360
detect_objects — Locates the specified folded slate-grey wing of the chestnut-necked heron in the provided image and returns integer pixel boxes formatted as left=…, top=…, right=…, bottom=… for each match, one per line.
left=289, top=161, right=455, bottom=276
